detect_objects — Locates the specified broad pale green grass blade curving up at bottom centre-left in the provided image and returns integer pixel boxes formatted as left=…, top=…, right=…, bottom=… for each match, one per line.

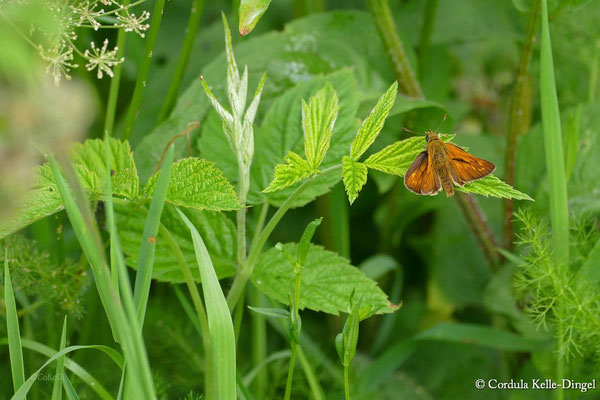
left=177, top=209, right=236, bottom=400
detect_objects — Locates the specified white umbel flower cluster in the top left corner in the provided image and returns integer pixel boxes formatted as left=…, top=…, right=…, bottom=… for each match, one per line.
left=8, top=0, right=150, bottom=86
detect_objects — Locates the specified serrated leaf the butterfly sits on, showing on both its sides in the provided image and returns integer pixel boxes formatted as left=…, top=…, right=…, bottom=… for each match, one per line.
left=365, top=134, right=533, bottom=201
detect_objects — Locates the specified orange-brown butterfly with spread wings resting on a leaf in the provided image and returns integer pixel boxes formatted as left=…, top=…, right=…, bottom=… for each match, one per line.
left=404, top=114, right=496, bottom=197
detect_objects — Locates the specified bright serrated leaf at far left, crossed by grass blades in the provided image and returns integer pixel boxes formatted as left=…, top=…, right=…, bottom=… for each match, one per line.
left=0, top=139, right=139, bottom=238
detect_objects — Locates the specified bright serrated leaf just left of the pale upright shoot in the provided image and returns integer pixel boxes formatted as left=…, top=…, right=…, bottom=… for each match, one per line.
left=144, top=157, right=240, bottom=211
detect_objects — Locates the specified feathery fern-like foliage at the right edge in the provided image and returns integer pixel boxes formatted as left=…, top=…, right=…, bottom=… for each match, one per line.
left=515, top=208, right=600, bottom=358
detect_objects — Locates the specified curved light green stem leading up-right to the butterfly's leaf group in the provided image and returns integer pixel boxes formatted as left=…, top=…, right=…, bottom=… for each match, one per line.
left=227, top=164, right=342, bottom=311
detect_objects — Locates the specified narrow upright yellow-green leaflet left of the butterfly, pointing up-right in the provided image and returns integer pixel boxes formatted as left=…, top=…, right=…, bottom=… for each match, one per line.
left=350, top=82, right=398, bottom=160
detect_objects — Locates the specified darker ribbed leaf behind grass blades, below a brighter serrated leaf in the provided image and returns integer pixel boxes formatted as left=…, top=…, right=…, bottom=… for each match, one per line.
left=115, top=204, right=236, bottom=283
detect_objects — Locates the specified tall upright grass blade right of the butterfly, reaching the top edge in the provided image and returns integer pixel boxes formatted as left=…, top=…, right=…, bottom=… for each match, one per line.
left=540, top=0, right=569, bottom=263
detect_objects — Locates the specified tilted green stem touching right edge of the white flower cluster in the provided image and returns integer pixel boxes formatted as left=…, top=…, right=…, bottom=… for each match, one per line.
left=122, top=0, right=165, bottom=140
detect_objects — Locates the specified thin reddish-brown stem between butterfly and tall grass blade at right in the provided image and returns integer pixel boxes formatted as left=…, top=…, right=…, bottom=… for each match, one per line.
left=504, top=0, right=541, bottom=249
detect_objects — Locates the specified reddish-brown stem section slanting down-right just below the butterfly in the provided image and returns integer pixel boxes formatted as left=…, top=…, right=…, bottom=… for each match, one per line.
left=456, top=192, right=500, bottom=272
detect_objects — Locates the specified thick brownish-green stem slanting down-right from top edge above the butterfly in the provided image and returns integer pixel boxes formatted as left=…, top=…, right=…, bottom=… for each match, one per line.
left=368, top=0, right=423, bottom=97
